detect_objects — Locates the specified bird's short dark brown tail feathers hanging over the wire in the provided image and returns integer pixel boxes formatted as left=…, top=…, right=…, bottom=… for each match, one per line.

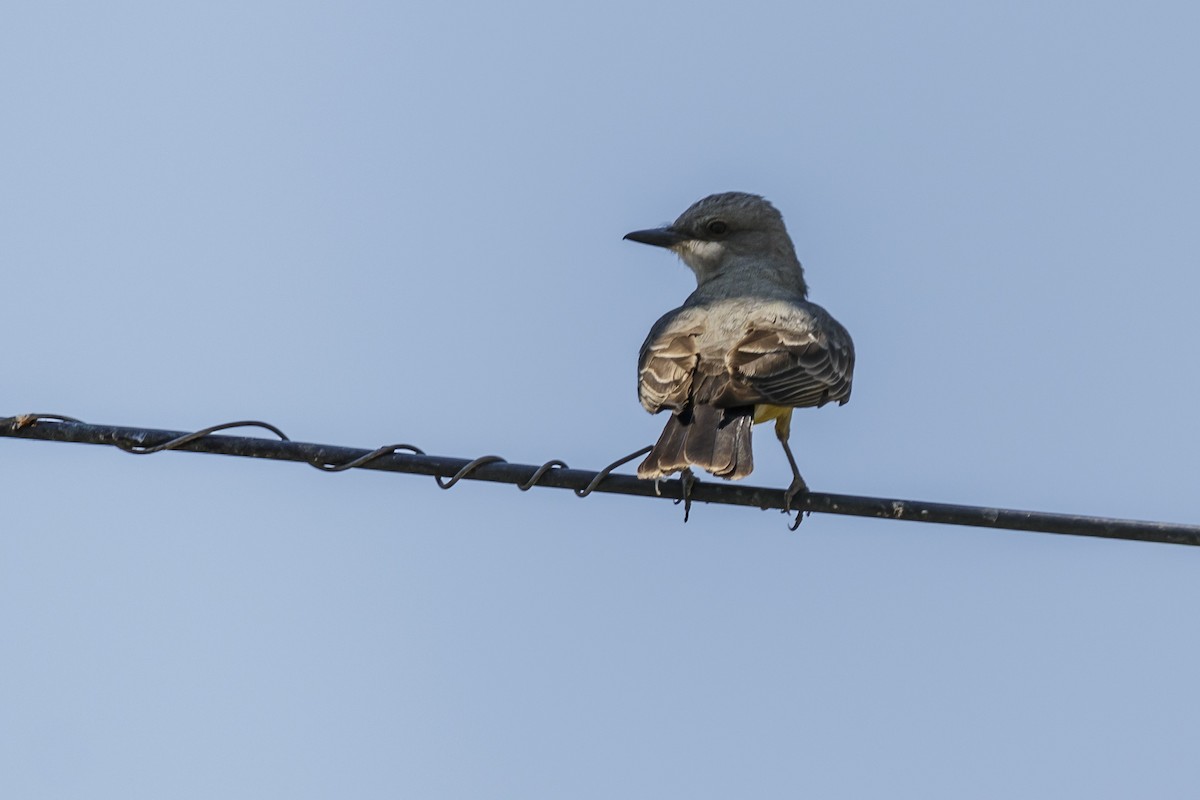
left=637, top=404, right=754, bottom=480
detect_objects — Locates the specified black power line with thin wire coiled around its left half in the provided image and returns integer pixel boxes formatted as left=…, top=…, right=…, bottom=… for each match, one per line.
left=0, top=414, right=1200, bottom=546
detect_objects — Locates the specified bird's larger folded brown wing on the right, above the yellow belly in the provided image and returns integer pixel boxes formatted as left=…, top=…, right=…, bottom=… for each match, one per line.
left=725, top=302, right=854, bottom=407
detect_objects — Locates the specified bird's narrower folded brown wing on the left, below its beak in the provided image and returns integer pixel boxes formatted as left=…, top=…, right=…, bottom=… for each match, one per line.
left=637, top=308, right=704, bottom=414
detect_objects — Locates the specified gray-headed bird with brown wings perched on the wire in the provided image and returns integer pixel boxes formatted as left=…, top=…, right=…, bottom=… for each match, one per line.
left=625, top=192, right=854, bottom=506
